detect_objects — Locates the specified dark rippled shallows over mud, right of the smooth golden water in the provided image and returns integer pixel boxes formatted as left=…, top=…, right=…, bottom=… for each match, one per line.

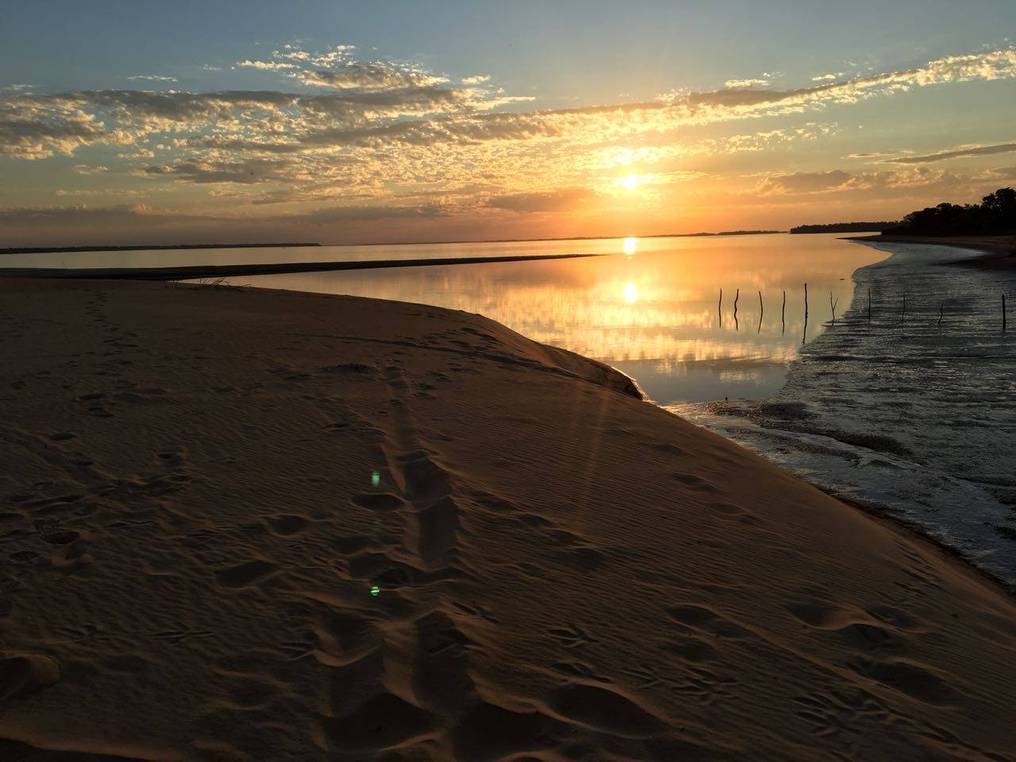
left=669, top=244, right=1016, bottom=586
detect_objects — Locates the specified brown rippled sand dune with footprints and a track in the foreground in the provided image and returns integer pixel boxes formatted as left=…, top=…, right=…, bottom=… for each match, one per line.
left=0, top=279, right=1016, bottom=760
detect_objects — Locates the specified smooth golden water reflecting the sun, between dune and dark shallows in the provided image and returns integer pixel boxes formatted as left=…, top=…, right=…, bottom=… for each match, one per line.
left=238, top=236, right=885, bottom=404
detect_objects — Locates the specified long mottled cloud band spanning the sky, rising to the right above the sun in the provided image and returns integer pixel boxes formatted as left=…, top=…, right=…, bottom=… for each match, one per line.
left=0, top=46, right=1016, bottom=165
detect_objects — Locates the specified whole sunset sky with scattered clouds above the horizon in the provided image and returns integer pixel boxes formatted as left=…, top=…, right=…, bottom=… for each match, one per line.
left=0, top=0, right=1016, bottom=247
